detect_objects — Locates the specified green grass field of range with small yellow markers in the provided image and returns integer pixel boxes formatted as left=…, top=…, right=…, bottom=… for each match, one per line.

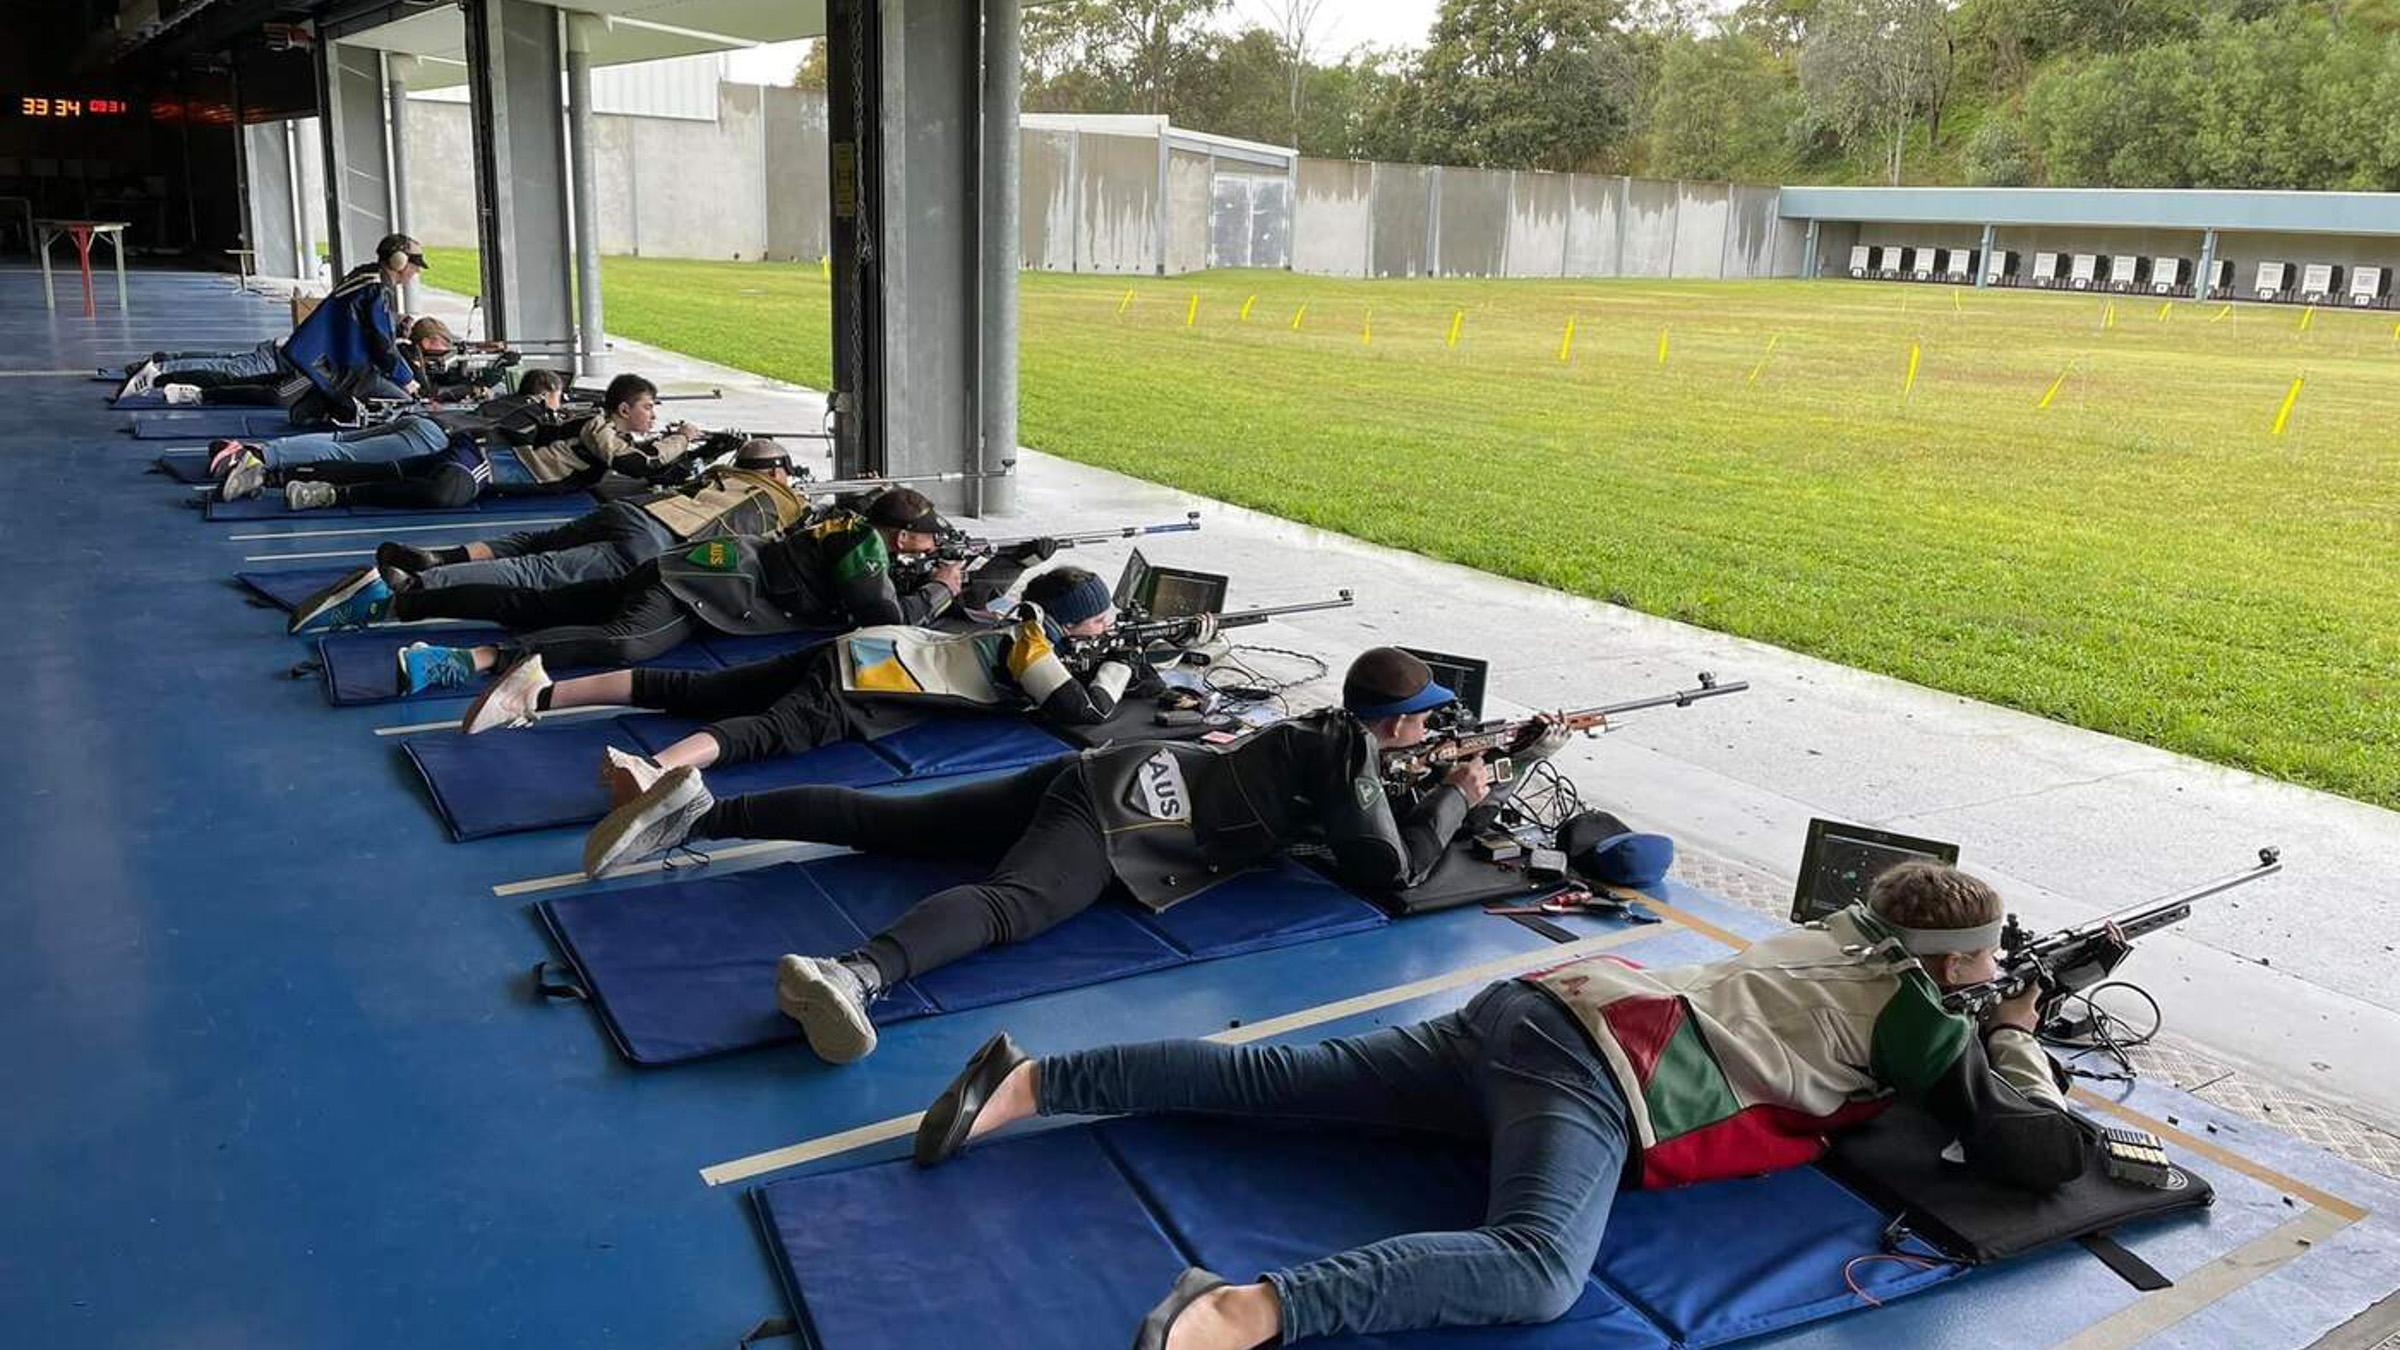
left=434, top=252, right=2400, bottom=807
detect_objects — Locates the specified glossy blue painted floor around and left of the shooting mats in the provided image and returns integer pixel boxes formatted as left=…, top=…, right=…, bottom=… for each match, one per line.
left=0, top=271, right=2400, bottom=1350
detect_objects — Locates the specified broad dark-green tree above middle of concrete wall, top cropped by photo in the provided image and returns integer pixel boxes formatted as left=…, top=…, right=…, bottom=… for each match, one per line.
left=1414, top=0, right=1639, bottom=168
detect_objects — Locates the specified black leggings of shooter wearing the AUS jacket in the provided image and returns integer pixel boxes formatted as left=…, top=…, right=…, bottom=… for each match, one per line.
left=691, top=754, right=1116, bottom=987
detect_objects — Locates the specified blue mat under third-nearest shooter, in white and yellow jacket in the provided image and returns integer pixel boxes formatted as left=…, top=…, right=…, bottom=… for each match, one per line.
left=401, top=713, right=1068, bottom=843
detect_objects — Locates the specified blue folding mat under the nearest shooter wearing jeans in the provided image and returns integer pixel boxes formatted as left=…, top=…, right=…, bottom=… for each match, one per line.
left=751, top=1117, right=1966, bottom=1350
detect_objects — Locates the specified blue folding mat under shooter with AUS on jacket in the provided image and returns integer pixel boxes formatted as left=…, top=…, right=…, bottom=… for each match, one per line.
left=535, top=853, right=1390, bottom=1064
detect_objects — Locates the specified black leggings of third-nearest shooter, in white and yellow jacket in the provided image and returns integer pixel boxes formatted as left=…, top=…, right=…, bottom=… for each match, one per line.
left=634, top=644, right=914, bottom=764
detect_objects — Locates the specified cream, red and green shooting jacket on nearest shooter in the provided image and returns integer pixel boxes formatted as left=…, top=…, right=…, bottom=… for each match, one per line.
left=1526, top=906, right=2086, bottom=1189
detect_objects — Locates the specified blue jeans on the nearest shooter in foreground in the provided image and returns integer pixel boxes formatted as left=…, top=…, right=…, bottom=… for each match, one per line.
left=1039, top=980, right=1630, bottom=1343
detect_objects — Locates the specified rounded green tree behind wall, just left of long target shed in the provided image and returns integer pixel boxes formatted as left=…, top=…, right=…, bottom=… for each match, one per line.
left=1649, top=31, right=1800, bottom=180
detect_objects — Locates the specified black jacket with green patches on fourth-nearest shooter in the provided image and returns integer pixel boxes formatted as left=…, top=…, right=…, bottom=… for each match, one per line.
left=658, top=512, right=950, bottom=634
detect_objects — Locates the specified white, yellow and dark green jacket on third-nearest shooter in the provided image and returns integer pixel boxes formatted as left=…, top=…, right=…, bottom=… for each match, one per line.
left=835, top=603, right=1133, bottom=725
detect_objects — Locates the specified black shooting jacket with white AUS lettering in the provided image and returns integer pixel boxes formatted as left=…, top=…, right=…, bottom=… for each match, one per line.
left=1080, top=709, right=1466, bottom=910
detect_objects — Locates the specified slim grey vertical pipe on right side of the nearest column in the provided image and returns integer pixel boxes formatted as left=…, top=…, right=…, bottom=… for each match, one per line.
left=970, top=0, right=1025, bottom=516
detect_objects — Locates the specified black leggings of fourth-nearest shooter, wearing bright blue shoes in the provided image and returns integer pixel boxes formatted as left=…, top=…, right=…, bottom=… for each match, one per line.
left=391, top=562, right=703, bottom=668
